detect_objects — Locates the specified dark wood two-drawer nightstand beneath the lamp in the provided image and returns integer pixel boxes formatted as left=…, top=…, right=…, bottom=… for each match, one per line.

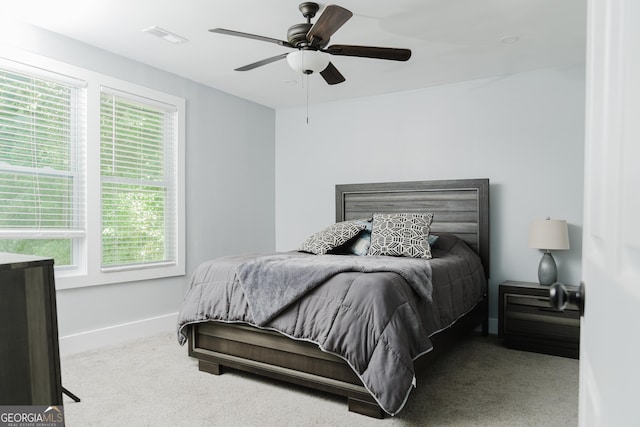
left=498, top=281, right=580, bottom=359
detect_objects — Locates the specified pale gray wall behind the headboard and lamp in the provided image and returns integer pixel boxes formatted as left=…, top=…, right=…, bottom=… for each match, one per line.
left=276, top=67, right=585, bottom=331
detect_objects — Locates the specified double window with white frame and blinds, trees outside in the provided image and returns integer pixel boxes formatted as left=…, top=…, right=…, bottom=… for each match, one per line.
left=0, top=54, right=185, bottom=288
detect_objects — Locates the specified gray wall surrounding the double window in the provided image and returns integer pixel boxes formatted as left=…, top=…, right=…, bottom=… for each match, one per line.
left=12, top=21, right=275, bottom=352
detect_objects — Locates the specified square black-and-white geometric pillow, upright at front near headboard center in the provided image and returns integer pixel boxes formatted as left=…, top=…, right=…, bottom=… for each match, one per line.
left=367, top=213, right=433, bottom=259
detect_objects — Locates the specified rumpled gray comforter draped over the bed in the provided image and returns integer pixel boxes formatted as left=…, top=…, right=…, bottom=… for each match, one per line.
left=178, top=236, right=486, bottom=415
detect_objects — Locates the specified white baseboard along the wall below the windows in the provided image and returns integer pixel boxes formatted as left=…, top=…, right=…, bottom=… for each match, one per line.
left=59, top=313, right=178, bottom=356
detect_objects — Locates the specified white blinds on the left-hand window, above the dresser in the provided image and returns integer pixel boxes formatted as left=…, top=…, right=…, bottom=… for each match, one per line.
left=0, top=67, right=85, bottom=264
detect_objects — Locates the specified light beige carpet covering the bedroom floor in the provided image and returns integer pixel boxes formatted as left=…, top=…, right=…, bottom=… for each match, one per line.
left=62, top=333, right=578, bottom=427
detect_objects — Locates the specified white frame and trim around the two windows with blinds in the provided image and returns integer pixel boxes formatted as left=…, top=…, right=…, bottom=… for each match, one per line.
left=0, top=47, right=186, bottom=289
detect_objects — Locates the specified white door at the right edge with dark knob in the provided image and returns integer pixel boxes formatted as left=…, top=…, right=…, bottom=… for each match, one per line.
left=580, top=0, right=640, bottom=426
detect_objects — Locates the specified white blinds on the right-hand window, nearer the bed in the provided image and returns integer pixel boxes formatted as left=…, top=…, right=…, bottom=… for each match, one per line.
left=100, top=88, right=177, bottom=270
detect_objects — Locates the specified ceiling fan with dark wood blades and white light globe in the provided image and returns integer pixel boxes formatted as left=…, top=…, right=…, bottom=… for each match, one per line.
left=209, top=2, right=411, bottom=85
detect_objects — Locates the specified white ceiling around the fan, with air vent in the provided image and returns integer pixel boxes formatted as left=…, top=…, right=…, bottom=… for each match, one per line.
left=3, top=0, right=586, bottom=108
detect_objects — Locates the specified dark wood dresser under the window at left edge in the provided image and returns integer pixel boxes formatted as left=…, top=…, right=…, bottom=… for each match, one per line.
left=0, top=253, right=62, bottom=405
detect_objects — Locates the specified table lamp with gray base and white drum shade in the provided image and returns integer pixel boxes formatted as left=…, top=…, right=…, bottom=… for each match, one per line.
left=529, top=218, right=569, bottom=285
